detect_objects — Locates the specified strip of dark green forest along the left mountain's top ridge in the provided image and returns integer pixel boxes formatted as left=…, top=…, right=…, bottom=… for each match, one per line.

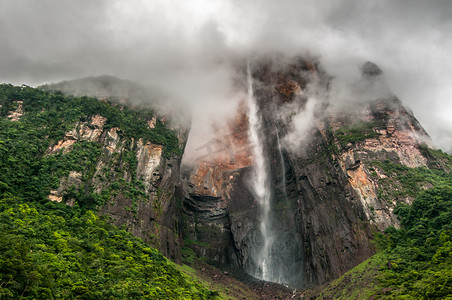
left=0, top=84, right=182, bottom=155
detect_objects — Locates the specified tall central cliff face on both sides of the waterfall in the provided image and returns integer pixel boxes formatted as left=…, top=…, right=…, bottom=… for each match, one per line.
left=184, top=59, right=429, bottom=286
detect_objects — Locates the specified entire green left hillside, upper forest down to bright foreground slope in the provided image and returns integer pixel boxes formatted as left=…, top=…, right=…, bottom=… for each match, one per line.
left=0, top=85, right=216, bottom=299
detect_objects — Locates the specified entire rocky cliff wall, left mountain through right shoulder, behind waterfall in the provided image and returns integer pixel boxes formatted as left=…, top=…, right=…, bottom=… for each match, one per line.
left=35, top=59, right=435, bottom=287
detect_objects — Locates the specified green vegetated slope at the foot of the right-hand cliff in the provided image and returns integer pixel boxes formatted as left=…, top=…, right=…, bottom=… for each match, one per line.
left=306, top=148, right=452, bottom=299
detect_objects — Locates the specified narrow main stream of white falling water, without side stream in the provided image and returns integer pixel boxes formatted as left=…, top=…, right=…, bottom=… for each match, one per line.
left=247, top=62, right=274, bottom=281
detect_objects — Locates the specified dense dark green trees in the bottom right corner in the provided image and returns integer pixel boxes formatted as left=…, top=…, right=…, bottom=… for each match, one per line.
left=380, top=186, right=452, bottom=299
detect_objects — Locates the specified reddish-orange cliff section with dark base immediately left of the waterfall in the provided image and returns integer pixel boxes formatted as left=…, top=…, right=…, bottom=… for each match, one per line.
left=184, top=105, right=256, bottom=267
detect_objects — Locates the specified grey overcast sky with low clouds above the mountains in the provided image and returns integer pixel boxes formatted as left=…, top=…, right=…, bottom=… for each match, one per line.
left=0, top=0, right=452, bottom=151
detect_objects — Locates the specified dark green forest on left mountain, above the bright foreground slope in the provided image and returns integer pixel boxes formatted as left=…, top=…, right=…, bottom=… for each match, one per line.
left=0, top=85, right=182, bottom=209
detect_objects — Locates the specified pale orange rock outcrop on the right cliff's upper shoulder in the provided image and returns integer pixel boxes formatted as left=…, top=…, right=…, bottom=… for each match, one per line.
left=329, top=98, right=430, bottom=230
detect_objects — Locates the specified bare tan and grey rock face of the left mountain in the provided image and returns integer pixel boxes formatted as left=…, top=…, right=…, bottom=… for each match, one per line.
left=47, top=115, right=186, bottom=261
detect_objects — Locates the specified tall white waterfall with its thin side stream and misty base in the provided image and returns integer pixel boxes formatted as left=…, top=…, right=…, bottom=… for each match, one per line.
left=244, top=62, right=302, bottom=286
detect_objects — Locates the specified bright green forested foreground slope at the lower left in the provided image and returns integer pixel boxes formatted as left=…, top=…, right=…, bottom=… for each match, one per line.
left=0, top=198, right=216, bottom=299
